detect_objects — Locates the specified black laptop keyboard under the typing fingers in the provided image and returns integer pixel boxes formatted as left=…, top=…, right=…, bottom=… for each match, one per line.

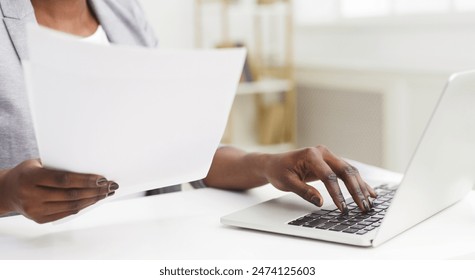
left=288, top=185, right=396, bottom=235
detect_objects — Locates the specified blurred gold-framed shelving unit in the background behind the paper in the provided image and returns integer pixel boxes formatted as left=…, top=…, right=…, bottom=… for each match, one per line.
left=195, top=0, right=296, bottom=145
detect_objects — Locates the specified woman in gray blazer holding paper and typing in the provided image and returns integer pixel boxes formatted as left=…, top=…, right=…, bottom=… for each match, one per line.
left=0, top=0, right=376, bottom=223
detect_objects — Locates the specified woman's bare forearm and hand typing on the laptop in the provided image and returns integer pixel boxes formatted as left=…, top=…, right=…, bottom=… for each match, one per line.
left=204, top=146, right=376, bottom=212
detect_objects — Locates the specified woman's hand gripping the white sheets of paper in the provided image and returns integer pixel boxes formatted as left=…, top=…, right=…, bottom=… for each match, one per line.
left=0, top=160, right=119, bottom=224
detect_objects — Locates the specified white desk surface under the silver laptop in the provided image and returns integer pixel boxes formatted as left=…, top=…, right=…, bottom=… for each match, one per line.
left=0, top=180, right=475, bottom=260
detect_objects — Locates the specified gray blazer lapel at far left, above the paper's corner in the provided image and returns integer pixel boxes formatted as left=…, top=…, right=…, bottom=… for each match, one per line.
left=0, top=0, right=36, bottom=60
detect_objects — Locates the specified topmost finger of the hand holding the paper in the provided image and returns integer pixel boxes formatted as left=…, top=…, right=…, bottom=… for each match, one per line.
left=31, top=168, right=108, bottom=188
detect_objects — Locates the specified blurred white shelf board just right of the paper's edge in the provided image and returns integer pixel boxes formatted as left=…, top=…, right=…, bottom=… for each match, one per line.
left=237, top=78, right=292, bottom=95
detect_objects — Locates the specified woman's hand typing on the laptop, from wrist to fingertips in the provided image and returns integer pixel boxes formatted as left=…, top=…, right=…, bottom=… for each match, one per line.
left=264, top=146, right=376, bottom=213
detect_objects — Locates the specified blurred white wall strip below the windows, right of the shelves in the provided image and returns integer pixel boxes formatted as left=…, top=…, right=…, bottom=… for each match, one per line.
left=295, top=16, right=475, bottom=73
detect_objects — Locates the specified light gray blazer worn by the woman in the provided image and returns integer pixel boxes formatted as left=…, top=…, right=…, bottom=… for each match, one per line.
left=0, top=0, right=158, bottom=169
